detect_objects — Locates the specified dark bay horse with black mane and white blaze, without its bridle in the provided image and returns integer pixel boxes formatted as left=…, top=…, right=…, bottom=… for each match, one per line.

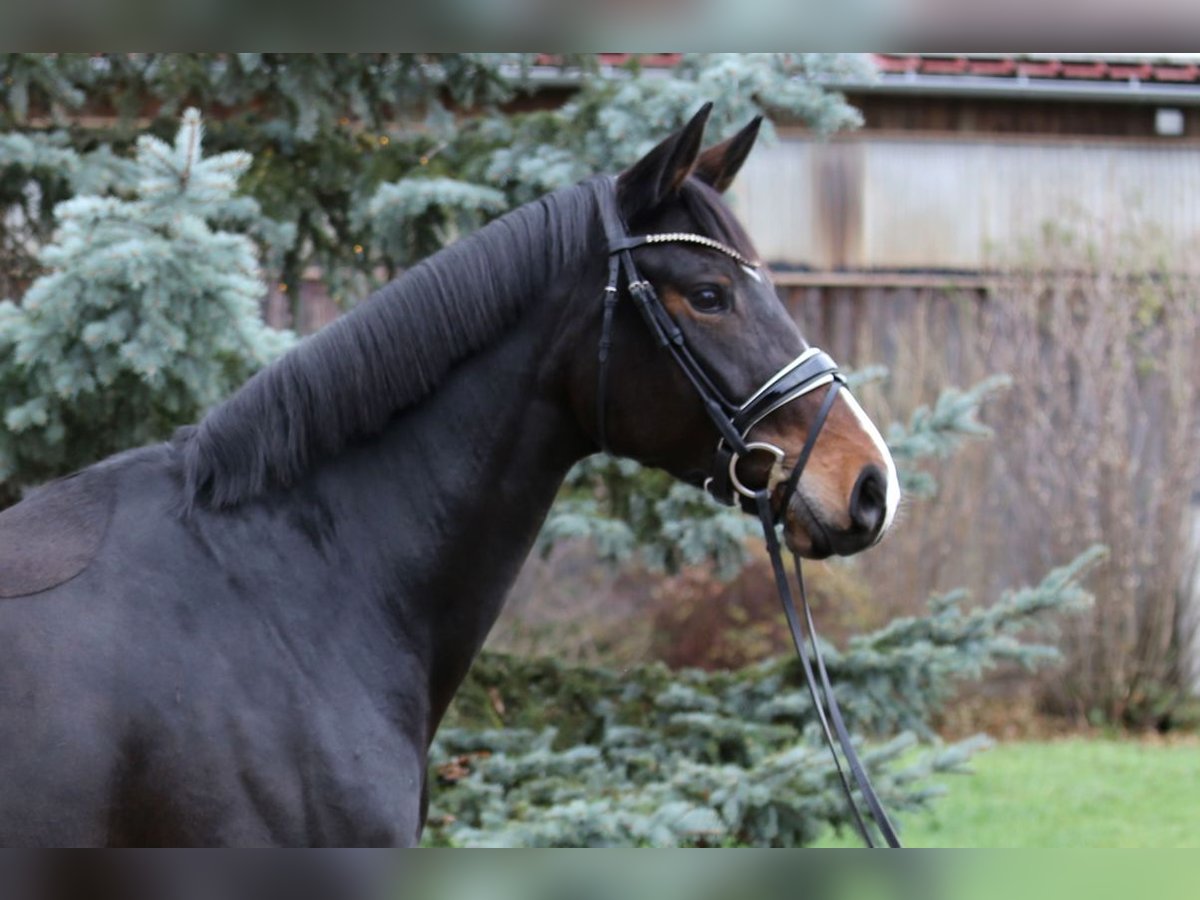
left=0, top=108, right=899, bottom=846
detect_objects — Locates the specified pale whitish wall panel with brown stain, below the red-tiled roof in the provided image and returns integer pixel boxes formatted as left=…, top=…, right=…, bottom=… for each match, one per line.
left=731, top=133, right=1200, bottom=272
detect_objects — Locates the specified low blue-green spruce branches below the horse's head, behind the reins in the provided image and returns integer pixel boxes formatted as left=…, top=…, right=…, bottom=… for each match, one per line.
left=427, top=550, right=1102, bottom=846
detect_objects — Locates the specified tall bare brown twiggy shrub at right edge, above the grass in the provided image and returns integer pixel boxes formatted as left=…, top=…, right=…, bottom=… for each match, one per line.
left=988, top=226, right=1200, bottom=726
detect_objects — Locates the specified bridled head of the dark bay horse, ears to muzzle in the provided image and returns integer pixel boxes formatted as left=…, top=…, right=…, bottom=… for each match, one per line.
left=572, top=107, right=900, bottom=558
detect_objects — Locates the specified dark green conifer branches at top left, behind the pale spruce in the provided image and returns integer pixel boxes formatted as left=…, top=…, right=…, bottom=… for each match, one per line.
left=0, top=53, right=528, bottom=314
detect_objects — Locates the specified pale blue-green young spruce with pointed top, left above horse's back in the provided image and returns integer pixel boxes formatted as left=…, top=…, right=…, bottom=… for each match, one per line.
left=0, top=110, right=292, bottom=494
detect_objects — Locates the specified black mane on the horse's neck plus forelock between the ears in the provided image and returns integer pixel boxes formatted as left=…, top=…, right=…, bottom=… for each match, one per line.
left=182, top=180, right=752, bottom=506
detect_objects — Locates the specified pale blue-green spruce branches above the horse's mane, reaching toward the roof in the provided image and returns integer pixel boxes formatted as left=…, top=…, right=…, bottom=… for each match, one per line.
left=354, top=53, right=869, bottom=285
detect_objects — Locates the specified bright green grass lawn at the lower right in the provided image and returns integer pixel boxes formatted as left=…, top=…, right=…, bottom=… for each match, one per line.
left=821, top=738, right=1200, bottom=847
